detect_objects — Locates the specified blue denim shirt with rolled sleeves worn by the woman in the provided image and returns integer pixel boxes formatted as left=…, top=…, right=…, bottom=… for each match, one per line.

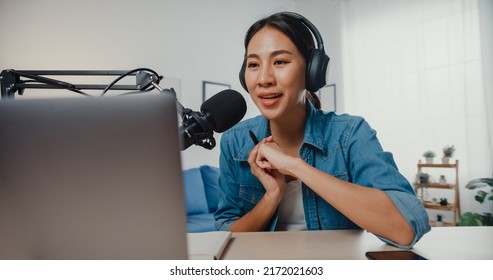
left=215, top=102, right=430, bottom=248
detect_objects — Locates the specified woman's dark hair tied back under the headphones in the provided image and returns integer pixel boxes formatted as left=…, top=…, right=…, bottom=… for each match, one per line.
left=245, top=12, right=321, bottom=109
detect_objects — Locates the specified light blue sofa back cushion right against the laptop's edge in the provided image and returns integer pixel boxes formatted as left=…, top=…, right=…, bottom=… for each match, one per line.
left=183, top=167, right=209, bottom=215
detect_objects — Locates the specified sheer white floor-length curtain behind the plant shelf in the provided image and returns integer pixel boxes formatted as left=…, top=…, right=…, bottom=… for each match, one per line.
left=341, top=0, right=492, bottom=212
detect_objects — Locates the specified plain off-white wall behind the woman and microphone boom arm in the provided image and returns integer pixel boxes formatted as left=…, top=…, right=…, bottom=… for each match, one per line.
left=0, top=0, right=342, bottom=168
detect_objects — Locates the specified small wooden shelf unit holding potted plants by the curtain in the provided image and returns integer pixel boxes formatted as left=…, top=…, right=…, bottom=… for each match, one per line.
left=414, top=160, right=460, bottom=226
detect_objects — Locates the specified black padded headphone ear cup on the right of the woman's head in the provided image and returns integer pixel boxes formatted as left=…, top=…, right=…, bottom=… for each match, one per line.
left=306, top=49, right=330, bottom=92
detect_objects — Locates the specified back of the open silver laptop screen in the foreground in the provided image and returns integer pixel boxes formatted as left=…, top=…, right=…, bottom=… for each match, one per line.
left=0, top=95, right=187, bottom=260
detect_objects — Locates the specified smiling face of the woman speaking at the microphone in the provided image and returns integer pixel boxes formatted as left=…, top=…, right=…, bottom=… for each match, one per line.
left=245, top=27, right=306, bottom=120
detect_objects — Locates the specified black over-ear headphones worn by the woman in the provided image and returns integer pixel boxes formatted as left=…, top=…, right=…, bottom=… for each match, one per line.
left=240, top=12, right=330, bottom=92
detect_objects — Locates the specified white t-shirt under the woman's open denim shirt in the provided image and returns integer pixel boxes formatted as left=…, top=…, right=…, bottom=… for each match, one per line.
left=276, top=179, right=307, bottom=231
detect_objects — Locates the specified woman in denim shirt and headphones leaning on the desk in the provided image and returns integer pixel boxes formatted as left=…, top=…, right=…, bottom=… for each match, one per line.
left=215, top=12, right=430, bottom=248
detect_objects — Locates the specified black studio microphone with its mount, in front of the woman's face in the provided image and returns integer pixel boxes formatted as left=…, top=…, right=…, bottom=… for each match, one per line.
left=179, top=89, right=246, bottom=151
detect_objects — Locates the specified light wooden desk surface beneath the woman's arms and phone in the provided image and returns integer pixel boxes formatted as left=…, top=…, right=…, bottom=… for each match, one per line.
left=221, top=227, right=493, bottom=260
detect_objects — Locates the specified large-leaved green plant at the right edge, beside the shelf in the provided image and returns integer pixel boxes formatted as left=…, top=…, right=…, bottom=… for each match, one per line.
left=459, top=178, right=493, bottom=226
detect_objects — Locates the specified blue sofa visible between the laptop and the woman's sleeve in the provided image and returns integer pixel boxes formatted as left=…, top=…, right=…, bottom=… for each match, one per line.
left=183, top=165, right=219, bottom=232
